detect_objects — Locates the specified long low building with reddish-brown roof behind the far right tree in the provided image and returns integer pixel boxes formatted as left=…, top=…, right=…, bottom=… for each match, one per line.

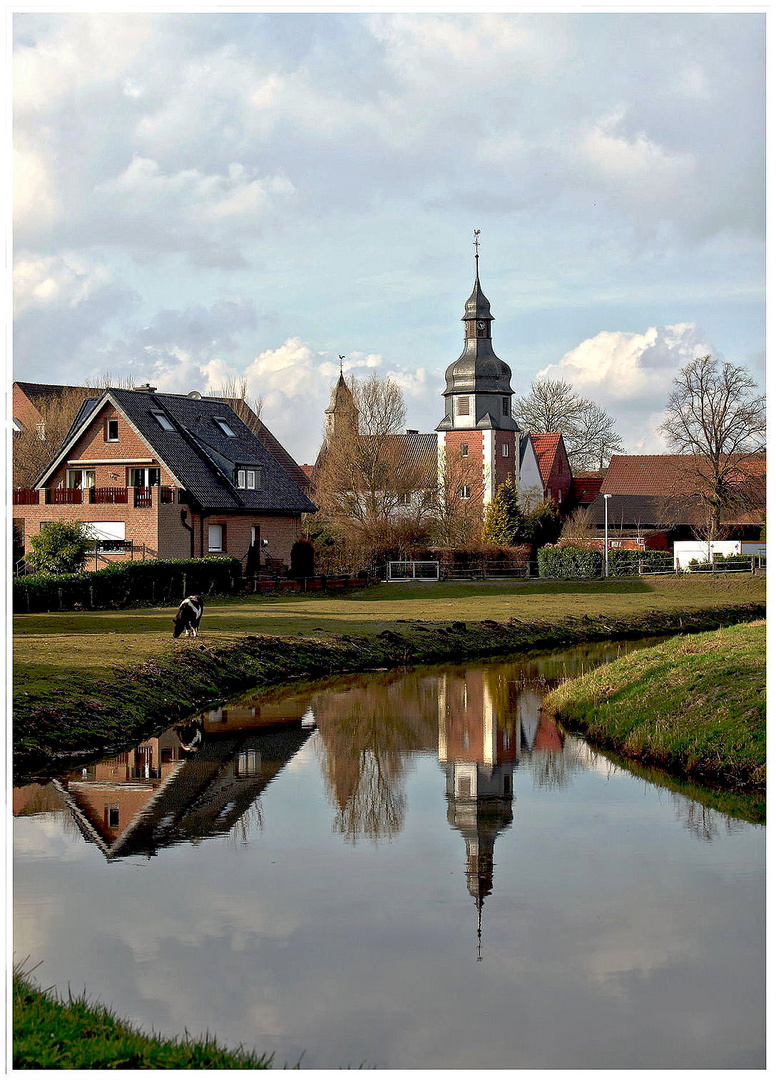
left=590, top=454, right=766, bottom=550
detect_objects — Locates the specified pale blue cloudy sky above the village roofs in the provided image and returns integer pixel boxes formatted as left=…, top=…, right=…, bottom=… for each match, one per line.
left=13, top=11, right=765, bottom=462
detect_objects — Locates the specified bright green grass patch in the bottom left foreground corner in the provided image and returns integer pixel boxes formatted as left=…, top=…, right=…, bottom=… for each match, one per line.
left=13, top=974, right=272, bottom=1069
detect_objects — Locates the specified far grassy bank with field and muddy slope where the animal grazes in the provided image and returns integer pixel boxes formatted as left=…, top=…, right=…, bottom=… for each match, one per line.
left=14, top=575, right=765, bottom=772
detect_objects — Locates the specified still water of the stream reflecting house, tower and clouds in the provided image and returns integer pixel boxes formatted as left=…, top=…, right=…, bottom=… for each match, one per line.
left=14, top=647, right=765, bottom=1069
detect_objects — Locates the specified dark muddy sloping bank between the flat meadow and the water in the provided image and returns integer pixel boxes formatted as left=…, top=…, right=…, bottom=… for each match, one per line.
left=13, top=603, right=765, bottom=779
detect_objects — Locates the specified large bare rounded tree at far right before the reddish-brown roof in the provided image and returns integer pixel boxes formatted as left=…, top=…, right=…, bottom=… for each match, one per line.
left=659, top=356, right=765, bottom=540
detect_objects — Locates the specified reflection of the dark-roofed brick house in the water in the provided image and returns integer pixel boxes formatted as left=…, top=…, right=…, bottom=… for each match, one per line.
left=54, top=721, right=312, bottom=859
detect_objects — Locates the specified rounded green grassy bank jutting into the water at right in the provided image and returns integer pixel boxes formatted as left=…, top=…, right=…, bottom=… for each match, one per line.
left=545, top=622, right=765, bottom=792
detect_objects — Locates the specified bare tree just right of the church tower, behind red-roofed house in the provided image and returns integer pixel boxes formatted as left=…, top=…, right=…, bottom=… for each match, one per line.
left=513, top=379, right=625, bottom=472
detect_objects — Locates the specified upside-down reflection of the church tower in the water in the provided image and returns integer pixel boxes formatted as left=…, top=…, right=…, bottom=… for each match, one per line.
left=439, top=671, right=519, bottom=959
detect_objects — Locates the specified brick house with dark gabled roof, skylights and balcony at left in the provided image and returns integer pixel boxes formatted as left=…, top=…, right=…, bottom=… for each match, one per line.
left=13, top=386, right=315, bottom=566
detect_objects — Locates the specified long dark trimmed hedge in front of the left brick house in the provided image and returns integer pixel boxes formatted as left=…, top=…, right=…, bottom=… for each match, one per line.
left=13, top=556, right=242, bottom=613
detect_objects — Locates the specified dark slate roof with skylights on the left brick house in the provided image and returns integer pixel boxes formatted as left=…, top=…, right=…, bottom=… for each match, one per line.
left=37, top=389, right=316, bottom=513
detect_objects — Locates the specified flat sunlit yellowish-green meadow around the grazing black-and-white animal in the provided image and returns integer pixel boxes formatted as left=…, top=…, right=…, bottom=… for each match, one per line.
left=14, top=575, right=765, bottom=680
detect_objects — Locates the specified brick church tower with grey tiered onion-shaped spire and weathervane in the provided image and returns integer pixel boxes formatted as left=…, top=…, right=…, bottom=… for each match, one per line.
left=436, top=229, right=519, bottom=507
